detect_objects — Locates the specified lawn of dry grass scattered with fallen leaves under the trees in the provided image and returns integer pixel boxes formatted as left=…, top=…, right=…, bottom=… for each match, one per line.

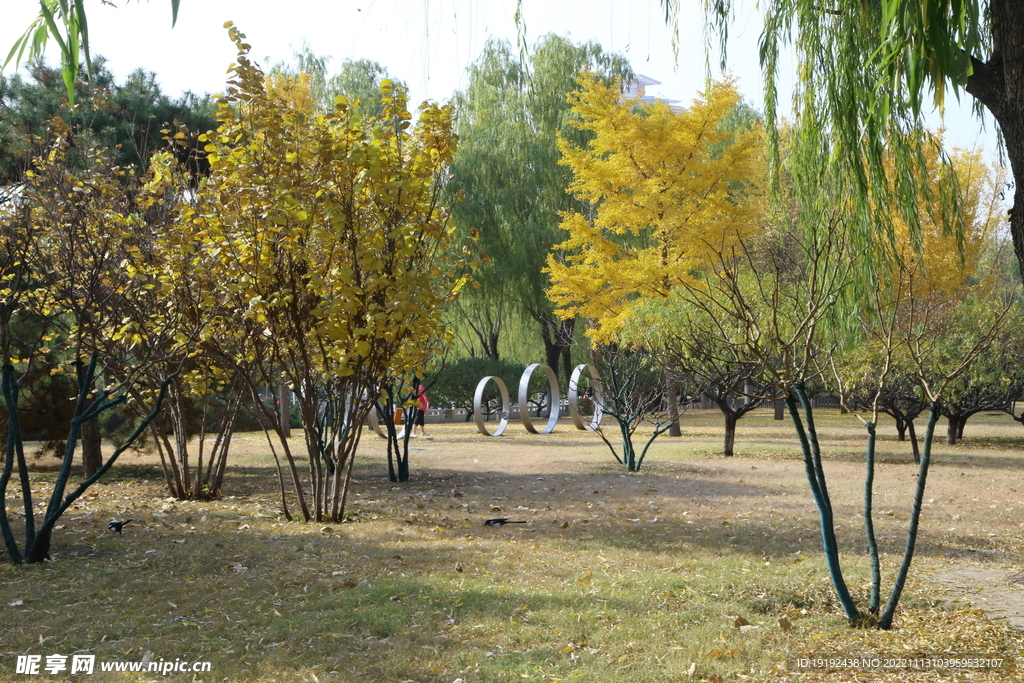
left=0, top=411, right=1024, bottom=683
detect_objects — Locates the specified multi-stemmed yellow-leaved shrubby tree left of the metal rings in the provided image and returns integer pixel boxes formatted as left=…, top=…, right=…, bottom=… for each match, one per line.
left=182, top=25, right=464, bottom=521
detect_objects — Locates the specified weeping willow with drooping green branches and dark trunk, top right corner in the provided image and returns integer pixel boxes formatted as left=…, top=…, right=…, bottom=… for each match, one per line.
left=700, top=0, right=1024, bottom=284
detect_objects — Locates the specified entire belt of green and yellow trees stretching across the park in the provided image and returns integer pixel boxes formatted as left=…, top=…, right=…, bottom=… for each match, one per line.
left=8, top=0, right=1024, bottom=629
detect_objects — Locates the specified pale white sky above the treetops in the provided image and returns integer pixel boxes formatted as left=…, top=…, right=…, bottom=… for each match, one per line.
left=0, top=0, right=995, bottom=152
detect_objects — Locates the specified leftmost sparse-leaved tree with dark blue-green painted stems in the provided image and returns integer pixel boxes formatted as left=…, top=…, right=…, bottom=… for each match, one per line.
left=0, top=120, right=194, bottom=563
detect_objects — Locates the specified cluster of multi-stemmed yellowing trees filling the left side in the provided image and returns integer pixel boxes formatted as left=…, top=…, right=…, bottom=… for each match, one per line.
left=0, top=27, right=471, bottom=562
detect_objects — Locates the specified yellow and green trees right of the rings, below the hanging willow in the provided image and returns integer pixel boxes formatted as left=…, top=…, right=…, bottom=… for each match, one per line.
left=548, top=60, right=1024, bottom=629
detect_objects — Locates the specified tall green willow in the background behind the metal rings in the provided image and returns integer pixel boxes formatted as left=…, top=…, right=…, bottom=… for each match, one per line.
left=449, top=35, right=632, bottom=382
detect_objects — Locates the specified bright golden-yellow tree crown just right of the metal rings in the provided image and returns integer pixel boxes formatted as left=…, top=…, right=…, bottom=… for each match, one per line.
left=548, top=75, right=765, bottom=342
